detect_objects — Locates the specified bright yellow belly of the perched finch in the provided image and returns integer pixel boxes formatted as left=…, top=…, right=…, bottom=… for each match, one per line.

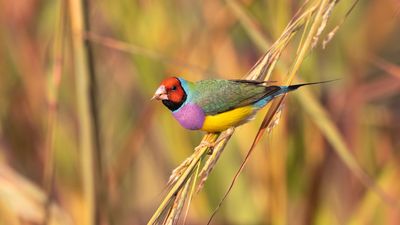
left=201, top=105, right=255, bottom=132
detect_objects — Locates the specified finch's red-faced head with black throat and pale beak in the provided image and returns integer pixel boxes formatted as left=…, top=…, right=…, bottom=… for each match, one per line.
left=152, top=77, right=186, bottom=111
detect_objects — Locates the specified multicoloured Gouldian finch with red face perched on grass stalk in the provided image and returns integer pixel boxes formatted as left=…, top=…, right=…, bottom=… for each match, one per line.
left=152, top=77, right=322, bottom=133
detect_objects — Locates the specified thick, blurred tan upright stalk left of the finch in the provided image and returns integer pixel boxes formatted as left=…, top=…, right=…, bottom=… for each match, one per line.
left=68, top=0, right=100, bottom=225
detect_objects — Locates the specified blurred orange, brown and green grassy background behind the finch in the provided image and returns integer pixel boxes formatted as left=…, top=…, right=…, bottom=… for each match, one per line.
left=0, top=0, right=400, bottom=225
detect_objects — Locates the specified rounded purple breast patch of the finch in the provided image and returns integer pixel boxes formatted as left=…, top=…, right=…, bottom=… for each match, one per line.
left=172, top=103, right=206, bottom=130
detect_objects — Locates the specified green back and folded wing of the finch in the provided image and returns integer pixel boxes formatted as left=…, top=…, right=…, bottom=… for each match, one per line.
left=192, top=80, right=280, bottom=115
